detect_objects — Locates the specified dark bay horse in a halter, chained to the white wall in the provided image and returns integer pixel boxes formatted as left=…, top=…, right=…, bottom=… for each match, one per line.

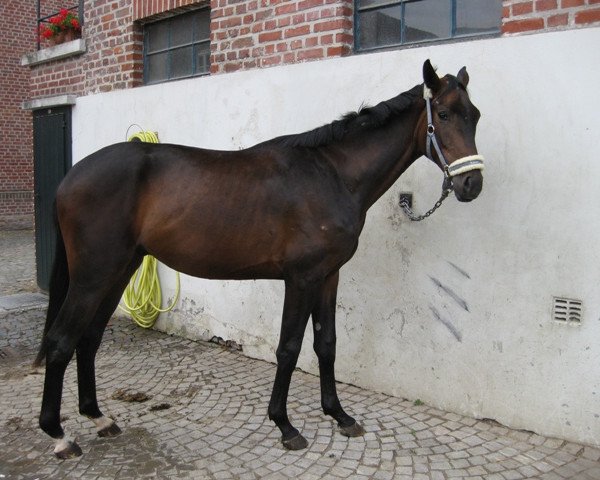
left=36, top=61, right=483, bottom=458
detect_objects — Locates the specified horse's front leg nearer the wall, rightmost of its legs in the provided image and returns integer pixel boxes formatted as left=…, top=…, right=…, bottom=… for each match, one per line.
left=312, top=272, right=365, bottom=437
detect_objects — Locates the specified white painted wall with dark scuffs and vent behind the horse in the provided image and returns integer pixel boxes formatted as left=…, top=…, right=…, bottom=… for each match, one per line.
left=73, top=28, right=600, bottom=445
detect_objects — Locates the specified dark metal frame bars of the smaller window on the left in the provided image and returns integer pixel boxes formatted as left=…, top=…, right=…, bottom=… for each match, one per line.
left=142, top=8, right=210, bottom=85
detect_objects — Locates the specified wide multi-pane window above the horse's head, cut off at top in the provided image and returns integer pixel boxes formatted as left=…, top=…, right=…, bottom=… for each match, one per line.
left=355, top=0, right=502, bottom=51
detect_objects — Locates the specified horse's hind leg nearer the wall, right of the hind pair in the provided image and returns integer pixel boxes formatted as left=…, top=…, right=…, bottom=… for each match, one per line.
left=76, top=256, right=141, bottom=437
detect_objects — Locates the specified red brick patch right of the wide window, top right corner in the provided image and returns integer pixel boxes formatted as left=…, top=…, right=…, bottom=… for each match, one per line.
left=502, top=0, right=600, bottom=34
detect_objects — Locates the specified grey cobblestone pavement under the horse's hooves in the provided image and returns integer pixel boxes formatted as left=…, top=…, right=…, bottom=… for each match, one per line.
left=0, top=231, right=600, bottom=480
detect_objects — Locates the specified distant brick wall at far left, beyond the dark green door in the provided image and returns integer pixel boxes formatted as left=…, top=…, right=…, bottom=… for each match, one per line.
left=0, top=0, right=35, bottom=228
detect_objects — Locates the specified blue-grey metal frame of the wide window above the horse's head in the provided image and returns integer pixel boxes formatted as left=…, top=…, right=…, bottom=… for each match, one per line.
left=354, top=0, right=502, bottom=53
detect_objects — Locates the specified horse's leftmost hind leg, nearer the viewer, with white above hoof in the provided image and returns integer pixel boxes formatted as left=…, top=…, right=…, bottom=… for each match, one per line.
left=39, top=282, right=112, bottom=458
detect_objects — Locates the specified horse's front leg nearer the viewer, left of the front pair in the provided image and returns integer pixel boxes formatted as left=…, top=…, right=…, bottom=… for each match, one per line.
left=268, top=280, right=315, bottom=450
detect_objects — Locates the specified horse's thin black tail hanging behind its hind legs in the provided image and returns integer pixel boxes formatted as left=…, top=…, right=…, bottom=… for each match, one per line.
left=33, top=217, right=69, bottom=367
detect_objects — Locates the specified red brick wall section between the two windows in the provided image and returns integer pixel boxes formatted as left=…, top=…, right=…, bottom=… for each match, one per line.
left=211, top=0, right=353, bottom=74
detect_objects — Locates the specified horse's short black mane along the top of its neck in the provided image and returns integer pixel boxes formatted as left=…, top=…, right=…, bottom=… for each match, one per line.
left=259, top=85, right=423, bottom=147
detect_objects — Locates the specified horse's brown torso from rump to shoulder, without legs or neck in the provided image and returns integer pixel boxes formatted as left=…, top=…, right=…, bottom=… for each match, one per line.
left=57, top=143, right=358, bottom=278
